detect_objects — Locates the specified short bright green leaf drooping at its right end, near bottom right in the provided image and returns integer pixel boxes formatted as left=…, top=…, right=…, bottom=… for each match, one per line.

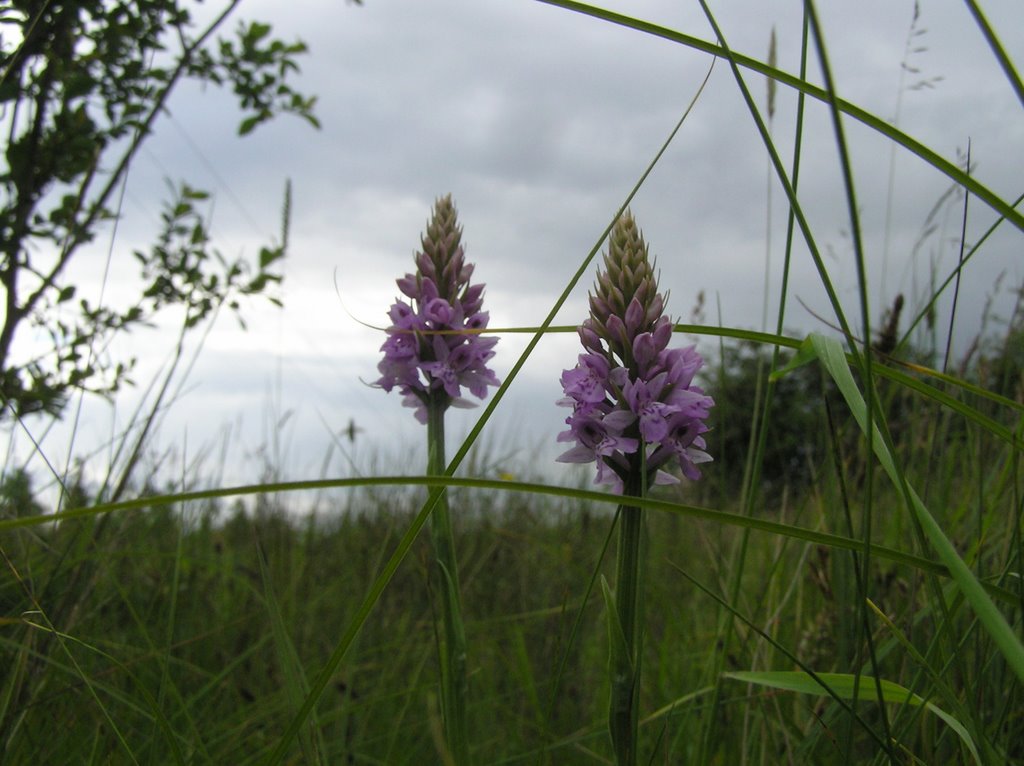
left=723, top=671, right=981, bottom=764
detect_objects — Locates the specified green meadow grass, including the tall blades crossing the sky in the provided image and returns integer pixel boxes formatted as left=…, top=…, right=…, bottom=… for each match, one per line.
left=0, top=0, right=1024, bottom=764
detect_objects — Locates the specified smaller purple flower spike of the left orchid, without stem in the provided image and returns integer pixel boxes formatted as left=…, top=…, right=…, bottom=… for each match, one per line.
left=374, top=195, right=500, bottom=423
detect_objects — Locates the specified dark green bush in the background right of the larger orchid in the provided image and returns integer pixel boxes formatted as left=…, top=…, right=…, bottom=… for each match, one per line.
left=703, top=295, right=991, bottom=503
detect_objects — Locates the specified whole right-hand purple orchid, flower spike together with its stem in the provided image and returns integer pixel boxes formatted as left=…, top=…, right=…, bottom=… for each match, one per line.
left=558, top=212, right=715, bottom=766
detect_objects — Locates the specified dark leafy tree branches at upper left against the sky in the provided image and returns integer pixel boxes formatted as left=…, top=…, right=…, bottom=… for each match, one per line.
left=0, top=0, right=316, bottom=420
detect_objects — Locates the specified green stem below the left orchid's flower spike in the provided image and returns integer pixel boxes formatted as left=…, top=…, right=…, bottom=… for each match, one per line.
left=427, top=391, right=469, bottom=766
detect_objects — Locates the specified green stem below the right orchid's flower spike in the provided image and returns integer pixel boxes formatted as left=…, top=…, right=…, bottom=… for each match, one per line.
left=608, top=470, right=645, bottom=766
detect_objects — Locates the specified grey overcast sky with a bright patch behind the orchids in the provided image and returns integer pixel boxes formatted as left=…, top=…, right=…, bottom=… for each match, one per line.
left=9, top=0, right=1024, bottom=499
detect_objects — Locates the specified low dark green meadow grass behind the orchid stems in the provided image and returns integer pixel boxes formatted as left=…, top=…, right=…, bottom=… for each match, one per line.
left=3, top=440, right=1021, bottom=764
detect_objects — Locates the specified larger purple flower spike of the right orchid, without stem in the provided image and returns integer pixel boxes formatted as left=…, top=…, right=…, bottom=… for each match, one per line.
left=558, top=212, right=715, bottom=492
